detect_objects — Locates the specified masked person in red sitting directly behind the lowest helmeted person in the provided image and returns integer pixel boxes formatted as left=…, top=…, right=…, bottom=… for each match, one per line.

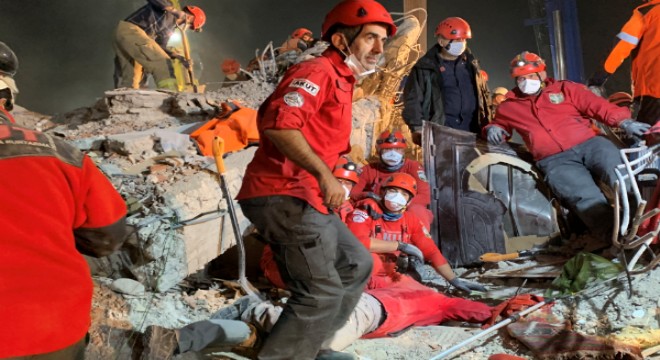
left=351, top=130, right=433, bottom=229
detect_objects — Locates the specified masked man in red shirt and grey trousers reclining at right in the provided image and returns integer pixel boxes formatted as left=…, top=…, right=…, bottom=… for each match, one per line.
left=484, top=51, right=649, bottom=243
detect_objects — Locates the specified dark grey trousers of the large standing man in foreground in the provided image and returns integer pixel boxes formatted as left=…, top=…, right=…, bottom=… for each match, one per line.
left=239, top=196, right=373, bottom=360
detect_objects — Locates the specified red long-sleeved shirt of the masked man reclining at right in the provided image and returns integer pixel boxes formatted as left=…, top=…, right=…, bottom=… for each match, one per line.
left=483, top=78, right=631, bottom=161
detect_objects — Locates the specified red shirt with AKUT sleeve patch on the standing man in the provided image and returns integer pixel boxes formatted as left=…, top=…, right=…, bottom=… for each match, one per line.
left=236, top=49, right=355, bottom=214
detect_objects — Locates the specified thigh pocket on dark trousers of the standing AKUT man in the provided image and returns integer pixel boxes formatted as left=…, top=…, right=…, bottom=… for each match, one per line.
left=281, top=236, right=334, bottom=280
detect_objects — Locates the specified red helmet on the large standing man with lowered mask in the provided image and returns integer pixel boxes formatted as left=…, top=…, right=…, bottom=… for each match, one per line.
left=321, top=0, right=396, bottom=41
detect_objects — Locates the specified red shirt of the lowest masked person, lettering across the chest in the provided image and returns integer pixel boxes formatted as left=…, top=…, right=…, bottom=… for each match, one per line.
left=346, top=204, right=447, bottom=282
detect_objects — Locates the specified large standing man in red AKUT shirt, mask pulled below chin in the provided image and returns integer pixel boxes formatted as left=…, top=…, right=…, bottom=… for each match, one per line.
left=237, top=0, right=396, bottom=359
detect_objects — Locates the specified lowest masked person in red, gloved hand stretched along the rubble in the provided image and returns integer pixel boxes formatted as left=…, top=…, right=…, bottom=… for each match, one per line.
left=346, top=173, right=486, bottom=293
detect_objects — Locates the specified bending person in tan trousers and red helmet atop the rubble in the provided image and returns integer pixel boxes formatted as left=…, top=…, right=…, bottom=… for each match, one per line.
left=114, top=0, right=206, bottom=91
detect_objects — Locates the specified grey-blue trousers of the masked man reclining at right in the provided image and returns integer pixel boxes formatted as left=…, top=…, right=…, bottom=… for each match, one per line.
left=536, top=136, right=622, bottom=239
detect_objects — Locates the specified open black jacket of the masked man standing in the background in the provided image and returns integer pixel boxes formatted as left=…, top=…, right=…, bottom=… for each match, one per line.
left=402, top=44, right=492, bottom=132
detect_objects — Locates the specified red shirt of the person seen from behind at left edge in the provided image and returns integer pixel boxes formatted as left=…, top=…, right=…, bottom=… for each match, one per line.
left=0, top=124, right=126, bottom=358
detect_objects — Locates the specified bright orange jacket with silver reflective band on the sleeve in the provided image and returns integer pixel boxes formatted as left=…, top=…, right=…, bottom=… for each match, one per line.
left=604, top=0, right=660, bottom=98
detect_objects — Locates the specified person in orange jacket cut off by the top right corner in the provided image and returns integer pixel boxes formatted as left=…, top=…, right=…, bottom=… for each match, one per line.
left=588, top=0, right=660, bottom=125
